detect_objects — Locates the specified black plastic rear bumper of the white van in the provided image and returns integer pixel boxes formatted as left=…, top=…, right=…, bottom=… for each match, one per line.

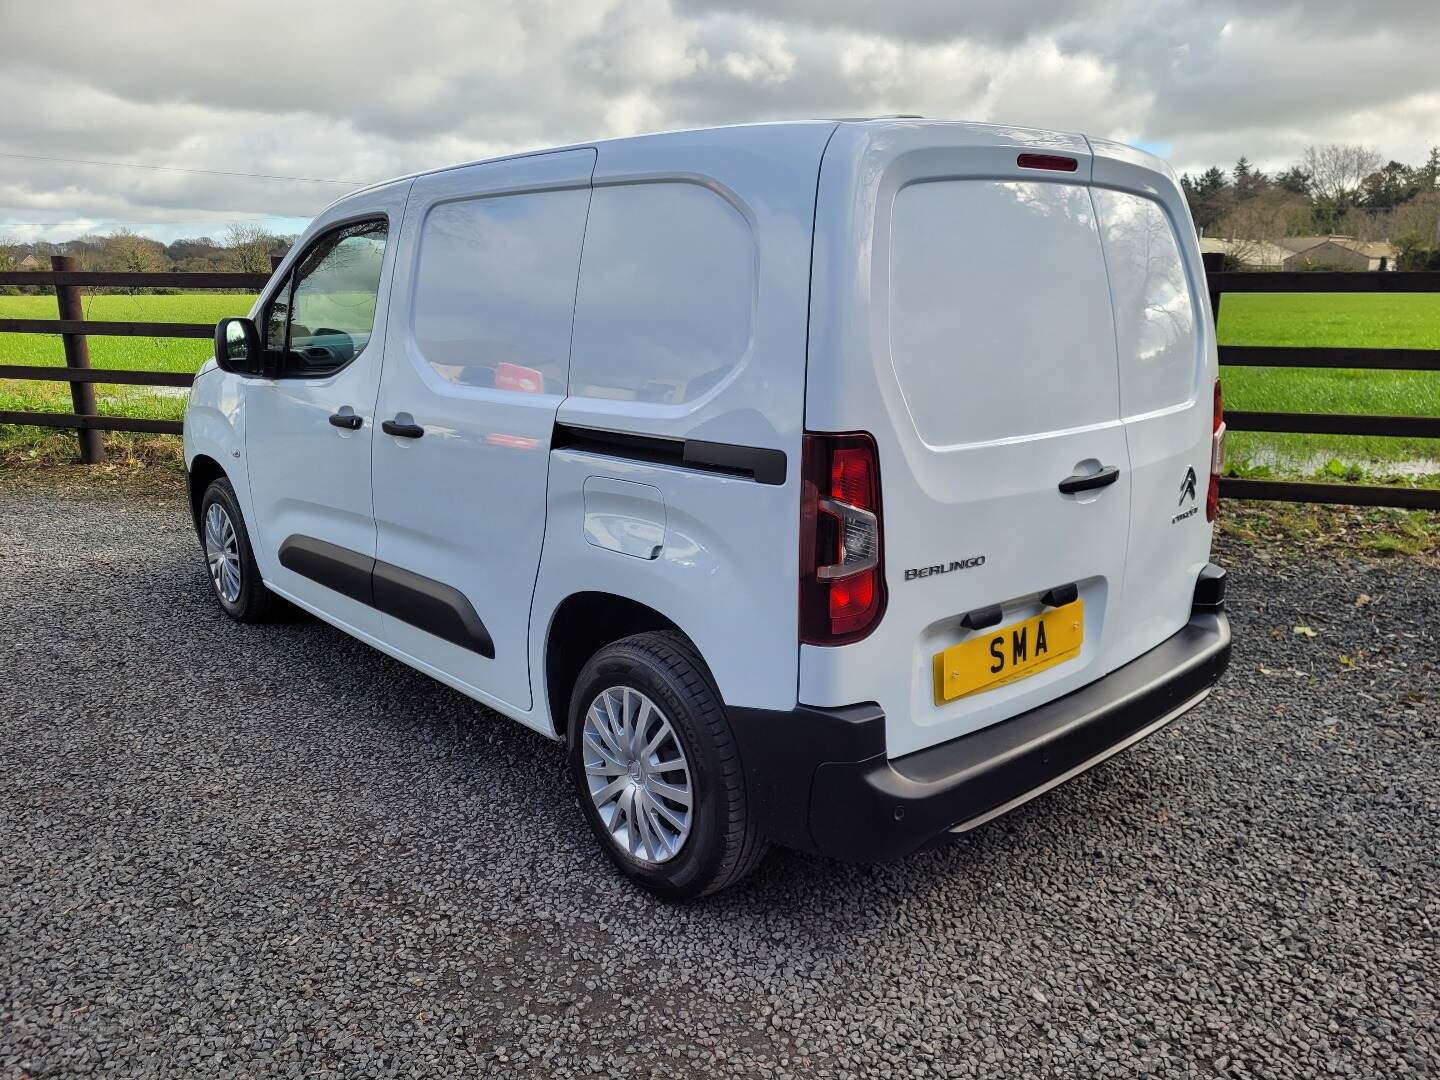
left=730, top=569, right=1230, bottom=863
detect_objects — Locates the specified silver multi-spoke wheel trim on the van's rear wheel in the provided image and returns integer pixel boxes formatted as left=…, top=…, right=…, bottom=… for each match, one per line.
left=580, top=685, right=696, bottom=864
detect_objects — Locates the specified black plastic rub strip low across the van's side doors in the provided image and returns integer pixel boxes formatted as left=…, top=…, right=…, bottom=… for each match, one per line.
left=279, top=534, right=495, bottom=660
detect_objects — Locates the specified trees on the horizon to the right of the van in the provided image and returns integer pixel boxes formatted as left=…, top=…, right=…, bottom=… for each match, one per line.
left=1181, top=144, right=1440, bottom=269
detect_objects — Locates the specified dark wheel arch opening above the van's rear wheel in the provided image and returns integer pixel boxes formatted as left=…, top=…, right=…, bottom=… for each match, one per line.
left=544, top=590, right=700, bottom=739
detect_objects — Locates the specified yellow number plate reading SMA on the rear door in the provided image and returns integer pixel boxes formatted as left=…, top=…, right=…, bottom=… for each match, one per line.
left=935, top=600, right=1084, bottom=706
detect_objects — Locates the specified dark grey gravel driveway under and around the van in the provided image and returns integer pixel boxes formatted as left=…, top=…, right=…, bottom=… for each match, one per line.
left=0, top=477, right=1440, bottom=1077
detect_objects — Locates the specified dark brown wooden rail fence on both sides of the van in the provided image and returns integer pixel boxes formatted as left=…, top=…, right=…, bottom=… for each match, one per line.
left=0, top=255, right=1440, bottom=511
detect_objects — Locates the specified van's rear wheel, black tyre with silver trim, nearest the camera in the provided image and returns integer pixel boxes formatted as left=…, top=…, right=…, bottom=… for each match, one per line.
left=569, top=632, right=766, bottom=900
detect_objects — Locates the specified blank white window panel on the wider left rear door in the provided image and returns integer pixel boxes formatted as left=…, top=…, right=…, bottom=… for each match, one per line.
left=888, top=180, right=1119, bottom=446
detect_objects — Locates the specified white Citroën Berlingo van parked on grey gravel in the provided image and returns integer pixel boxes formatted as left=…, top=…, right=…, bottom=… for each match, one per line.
left=184, top=120, right=1230, bottom=897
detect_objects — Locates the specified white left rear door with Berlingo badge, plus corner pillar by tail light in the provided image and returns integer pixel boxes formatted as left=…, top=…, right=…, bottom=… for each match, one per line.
left=801, top=121, right=1132, bottom=757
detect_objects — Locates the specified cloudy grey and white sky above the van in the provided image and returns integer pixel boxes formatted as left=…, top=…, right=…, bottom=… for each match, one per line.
left=0, top=0, right=1440, bottom=240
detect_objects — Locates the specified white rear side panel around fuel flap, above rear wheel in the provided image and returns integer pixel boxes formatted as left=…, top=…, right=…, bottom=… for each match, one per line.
left=530, top=122, right=835, bottom=728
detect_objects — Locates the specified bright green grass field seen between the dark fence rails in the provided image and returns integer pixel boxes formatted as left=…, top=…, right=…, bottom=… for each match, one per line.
left=0, top=294, right=1440, bottom=475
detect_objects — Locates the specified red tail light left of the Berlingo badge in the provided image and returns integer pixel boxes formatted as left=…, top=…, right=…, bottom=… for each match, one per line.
left=801, top=432, right=886, bottom=645
